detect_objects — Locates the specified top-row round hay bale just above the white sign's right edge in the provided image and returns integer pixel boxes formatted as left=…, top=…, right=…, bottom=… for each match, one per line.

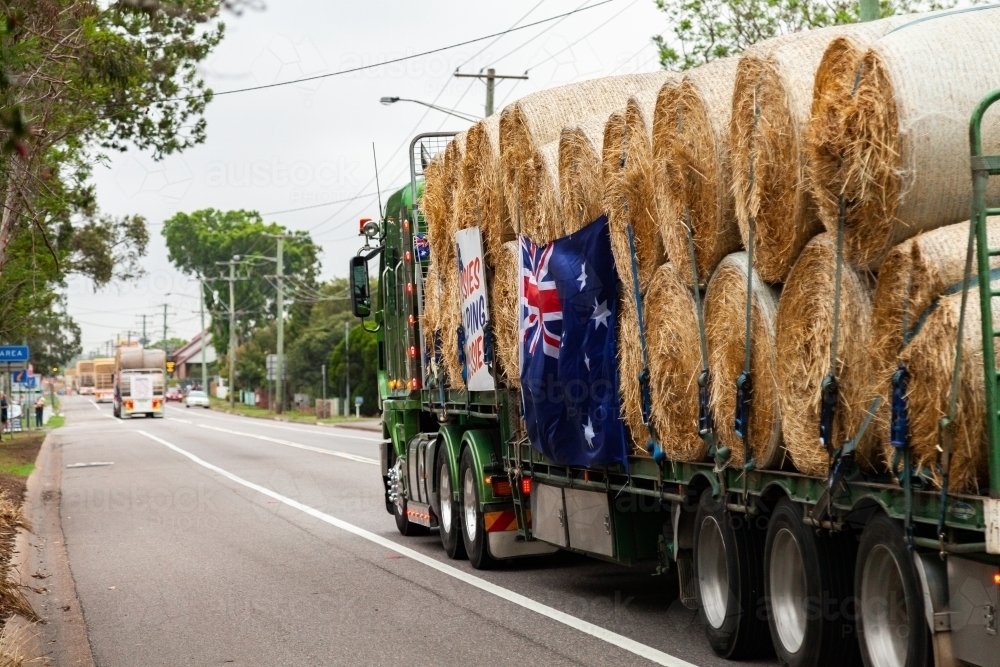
left=460, top=114, right=508, bottom=263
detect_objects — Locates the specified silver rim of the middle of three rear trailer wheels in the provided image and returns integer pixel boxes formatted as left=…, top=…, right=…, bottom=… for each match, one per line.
left=769, top=528, right=807, bottom=653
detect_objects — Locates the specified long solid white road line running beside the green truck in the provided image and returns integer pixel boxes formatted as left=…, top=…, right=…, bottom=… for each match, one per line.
left=137, top=431, right=695, bottom=667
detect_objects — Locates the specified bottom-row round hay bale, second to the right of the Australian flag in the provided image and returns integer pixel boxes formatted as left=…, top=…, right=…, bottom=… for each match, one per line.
left=640, top=264, right=706, bottom=461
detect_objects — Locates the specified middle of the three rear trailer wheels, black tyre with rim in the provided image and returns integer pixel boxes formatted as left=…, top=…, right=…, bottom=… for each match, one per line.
left=764, top=498, right=861, bottom=667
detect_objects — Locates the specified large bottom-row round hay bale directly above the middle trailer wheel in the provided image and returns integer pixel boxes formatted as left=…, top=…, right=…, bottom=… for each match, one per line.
left=775, top=234, right=881, bottom=477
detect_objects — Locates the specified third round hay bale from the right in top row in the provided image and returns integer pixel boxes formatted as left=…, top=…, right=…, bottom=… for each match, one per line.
left=653, top=58, right=740, bottom=285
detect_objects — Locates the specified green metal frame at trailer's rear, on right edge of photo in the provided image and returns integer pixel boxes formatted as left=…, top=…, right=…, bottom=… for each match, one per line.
left=964, top=90, right=1000, bottom=498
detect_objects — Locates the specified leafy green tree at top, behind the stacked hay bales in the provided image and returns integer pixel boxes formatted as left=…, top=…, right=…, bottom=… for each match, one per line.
left=653, top=0, right=955, bottom=70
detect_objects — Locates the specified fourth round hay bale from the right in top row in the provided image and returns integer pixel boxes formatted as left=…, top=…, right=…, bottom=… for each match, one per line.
left=603, top=89, right=666, bottom=291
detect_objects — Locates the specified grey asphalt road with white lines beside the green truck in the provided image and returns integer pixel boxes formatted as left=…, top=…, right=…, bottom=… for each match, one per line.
left=54, top=397, right=772, bottom=667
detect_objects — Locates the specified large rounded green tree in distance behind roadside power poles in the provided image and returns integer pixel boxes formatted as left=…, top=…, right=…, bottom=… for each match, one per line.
left=163, top=209, right=319, bottom=354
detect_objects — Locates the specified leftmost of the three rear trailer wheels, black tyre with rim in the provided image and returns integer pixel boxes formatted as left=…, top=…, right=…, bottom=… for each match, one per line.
left=694, top=489, right=771, bottom=660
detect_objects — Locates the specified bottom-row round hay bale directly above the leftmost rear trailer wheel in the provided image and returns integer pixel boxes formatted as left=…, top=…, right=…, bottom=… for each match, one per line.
left=705, top=252, right=783, bottom=469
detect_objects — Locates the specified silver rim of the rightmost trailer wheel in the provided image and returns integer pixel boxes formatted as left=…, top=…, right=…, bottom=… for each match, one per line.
left=861, top=544, right=910, bottom=667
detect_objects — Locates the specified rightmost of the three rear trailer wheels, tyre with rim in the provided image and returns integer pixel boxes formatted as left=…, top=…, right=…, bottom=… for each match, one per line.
left=854, top=514, right=932, bottom=667
